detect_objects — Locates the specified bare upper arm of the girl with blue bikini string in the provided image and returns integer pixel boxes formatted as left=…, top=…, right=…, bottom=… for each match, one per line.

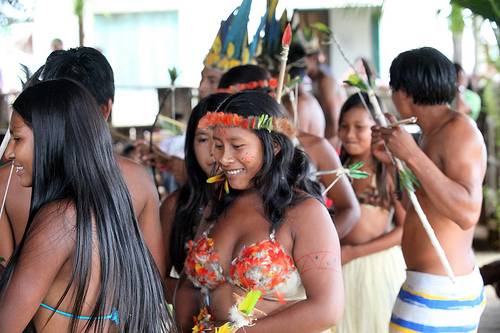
left=0, top=201, right=75, bottom=333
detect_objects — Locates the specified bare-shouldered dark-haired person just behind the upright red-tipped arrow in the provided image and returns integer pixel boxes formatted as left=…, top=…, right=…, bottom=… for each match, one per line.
left=283, top=44, right=325, bottom=138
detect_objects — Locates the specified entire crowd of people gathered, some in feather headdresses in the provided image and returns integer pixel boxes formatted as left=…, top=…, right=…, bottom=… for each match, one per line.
left=0, top=1, right=492, bottom=333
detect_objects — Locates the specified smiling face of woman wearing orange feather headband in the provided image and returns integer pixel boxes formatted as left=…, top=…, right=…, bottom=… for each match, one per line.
left=213, top=127, right=264, bottom=190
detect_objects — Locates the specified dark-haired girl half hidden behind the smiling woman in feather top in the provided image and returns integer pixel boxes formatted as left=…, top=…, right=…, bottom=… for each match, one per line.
left=160, top=93, right=229, bottom=329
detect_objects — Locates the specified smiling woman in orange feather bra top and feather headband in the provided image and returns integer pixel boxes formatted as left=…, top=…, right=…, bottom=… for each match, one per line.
left=184, top=91, right=343, bottom=333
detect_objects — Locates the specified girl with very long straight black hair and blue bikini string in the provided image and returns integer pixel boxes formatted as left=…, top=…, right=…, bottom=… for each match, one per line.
left=0, top=79, right=174, bottom=333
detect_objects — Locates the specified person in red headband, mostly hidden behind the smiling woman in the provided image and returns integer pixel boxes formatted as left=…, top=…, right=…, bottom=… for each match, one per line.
left=219, top=65, right=360, bottom=239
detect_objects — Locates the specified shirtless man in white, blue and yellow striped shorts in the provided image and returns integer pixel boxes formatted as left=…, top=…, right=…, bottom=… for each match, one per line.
left=373, top=47, right=486, bottom=332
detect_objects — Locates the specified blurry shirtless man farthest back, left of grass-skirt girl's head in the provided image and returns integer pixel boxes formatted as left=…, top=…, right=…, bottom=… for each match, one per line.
left=306, top=50, right=344, bottom=148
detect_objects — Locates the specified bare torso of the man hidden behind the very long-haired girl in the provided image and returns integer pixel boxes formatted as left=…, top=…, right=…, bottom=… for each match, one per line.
left=0, top=157, right=165, bottom=276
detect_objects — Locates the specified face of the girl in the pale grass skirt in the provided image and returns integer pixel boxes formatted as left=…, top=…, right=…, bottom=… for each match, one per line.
left=339, top=106, right=375, bottom=156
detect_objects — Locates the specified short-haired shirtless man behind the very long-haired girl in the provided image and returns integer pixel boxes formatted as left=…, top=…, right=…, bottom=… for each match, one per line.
left=0, top=47, right=165, bottom=277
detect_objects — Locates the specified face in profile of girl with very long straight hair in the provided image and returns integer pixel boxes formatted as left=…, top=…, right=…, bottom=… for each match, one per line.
left=5, top=111, right=34, bottom=187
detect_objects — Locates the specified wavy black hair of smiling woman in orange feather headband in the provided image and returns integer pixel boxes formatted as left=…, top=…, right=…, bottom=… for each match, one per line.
left=210, top=90, right=323, bottom=229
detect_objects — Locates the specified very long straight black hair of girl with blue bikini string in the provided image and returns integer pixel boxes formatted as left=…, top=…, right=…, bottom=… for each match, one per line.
left=0, top=79, right=175, bottom=332
